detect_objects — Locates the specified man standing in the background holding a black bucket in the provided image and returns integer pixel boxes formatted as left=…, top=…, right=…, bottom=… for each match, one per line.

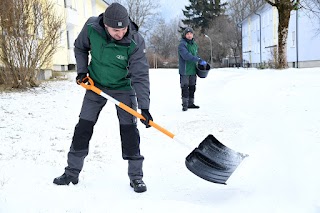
left=178, top=27, right=207, bottom=111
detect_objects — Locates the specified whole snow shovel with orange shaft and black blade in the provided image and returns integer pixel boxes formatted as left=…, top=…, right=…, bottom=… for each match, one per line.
left=80, top=77, right=248, bottom=184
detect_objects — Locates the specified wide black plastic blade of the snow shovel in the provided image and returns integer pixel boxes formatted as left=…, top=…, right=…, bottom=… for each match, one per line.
left=185, top=135, right=248, bottom=184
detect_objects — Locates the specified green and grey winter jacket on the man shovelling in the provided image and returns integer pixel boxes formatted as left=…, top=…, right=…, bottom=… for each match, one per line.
left=74, top=14, right=150, bottom=109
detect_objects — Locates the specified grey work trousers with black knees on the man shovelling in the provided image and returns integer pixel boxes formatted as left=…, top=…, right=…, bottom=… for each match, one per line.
left=65, top=90, right=144, bottom=180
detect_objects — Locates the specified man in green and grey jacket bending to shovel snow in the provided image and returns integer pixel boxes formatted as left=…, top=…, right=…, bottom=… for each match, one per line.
left=53, top=3, right=152, bottom=192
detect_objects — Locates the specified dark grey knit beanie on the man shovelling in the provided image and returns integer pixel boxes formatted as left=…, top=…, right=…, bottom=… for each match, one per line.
left=103, top=3, right=129, bottom=28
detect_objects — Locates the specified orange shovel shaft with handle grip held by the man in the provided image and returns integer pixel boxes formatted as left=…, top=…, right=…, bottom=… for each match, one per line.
left=80, top=77, right=175, bottom=138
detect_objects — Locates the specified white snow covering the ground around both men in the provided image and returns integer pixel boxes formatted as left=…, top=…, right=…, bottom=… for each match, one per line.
left=0, top=68, right=320, bottom=213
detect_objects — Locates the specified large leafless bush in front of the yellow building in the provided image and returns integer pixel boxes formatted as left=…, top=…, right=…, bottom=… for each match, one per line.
left=0, top=0, right=62, bottom=88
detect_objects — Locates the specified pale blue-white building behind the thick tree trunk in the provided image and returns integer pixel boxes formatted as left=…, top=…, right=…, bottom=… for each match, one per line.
left=241, top=4, right=320, bottom=68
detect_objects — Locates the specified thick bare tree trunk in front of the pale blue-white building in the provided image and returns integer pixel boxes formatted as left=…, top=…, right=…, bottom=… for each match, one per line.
left=265, top=0, right=300, bottom=69
